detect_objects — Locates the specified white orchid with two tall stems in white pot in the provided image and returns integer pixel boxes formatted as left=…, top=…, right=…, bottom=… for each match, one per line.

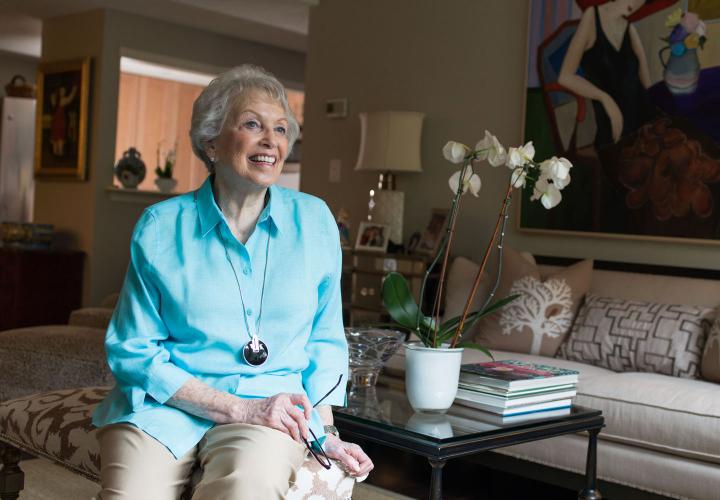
left=383, top=131, right=572, bottom=412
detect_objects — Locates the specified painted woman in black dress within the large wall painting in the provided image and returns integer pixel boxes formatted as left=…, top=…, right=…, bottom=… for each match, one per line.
left=558, top=0, right=720, bottom=234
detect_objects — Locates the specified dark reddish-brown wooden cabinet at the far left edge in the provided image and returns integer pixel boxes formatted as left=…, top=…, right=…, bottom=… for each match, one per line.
left=0, top=248, right=85, bottom=331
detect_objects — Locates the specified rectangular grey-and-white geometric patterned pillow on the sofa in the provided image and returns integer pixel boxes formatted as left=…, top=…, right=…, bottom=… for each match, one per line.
left=559, top=294, right=713, bottom=378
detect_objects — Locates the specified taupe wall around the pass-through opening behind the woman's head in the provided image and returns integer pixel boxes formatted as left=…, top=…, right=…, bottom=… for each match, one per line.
left=35, top=10, right=305, bottom=304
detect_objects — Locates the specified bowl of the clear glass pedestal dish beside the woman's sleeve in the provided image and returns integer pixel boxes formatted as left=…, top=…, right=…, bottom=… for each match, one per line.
left=345, top=327, right=405, bottom=387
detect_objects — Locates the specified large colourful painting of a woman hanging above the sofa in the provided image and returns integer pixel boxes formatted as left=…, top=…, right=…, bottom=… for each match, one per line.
left=518, top=0, right=720, bottom=242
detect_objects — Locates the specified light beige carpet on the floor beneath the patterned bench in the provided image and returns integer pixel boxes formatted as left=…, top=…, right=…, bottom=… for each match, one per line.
left=20, top=459, right=410, bottom=500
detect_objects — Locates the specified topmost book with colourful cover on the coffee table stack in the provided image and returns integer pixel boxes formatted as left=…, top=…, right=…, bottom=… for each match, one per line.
left=460, top=360, right=579, bottom=389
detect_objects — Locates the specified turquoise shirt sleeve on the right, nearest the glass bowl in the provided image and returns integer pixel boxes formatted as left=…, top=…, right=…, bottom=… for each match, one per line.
left=302, top=206, right=348, bottom=406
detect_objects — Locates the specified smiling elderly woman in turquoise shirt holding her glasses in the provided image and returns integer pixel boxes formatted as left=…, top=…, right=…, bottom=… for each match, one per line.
left=94, top=66, right=373, bottom=500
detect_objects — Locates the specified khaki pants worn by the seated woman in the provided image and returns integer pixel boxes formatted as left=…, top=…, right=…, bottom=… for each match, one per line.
left=98, top=424, right=306, bottom=500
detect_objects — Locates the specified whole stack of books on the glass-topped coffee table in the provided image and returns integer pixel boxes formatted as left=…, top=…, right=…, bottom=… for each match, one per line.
left=455, top=360, right=579, bottom=423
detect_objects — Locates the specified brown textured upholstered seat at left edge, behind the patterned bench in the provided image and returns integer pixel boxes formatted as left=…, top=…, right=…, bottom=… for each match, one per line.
left=0, top=325, right=114, bottom=401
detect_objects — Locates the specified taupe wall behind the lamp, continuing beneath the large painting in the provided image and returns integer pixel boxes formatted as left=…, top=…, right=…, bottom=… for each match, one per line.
left=301, top=0, right=720, bottom=268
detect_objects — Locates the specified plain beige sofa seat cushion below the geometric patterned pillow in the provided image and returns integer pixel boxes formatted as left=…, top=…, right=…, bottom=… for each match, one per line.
left=576, top=372, right=720, bottom=463
